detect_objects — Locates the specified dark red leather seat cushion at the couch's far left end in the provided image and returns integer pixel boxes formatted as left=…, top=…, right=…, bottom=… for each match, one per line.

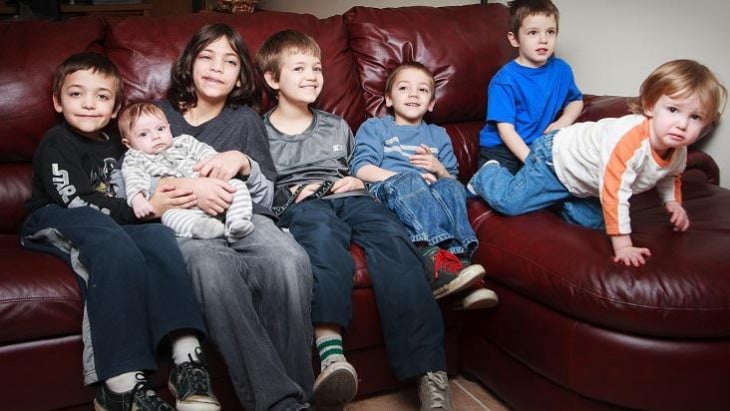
left=0, top=234, right=82, bottom=345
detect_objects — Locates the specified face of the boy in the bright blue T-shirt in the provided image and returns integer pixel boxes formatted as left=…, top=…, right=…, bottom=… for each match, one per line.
left=507, top=14, right=558, bottom=68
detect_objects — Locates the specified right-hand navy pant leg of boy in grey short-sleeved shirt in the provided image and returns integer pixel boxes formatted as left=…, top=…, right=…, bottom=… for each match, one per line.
left=334, top=197, right=446, bottom=380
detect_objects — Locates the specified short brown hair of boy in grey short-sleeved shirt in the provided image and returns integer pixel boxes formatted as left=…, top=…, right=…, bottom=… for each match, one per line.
left=256, top=30, right=322, bottom=85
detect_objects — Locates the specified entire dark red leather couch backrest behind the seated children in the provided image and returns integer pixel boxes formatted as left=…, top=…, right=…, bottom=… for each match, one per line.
left=0, top=4, right=514, bottom=233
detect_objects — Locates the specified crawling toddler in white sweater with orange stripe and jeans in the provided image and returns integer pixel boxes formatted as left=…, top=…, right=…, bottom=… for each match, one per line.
left=468, top=60, right=727, bottom=267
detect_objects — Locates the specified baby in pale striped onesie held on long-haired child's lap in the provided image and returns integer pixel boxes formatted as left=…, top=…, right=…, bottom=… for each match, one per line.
left=119, top=102, right=254, bottom=243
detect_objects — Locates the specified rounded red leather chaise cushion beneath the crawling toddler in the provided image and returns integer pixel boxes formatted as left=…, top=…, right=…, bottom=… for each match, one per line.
left=469, top=173, right=730, bottom=339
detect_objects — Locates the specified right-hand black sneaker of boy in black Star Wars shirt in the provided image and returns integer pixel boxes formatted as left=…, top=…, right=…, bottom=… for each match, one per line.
left=167, top=347, right=221, bottom=411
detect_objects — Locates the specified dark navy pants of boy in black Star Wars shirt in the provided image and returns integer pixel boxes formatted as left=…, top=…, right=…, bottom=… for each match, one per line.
left=22, top=204, right=205, bottom=383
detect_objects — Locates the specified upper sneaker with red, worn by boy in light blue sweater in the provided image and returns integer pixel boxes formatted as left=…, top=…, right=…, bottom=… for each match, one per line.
left=421, top=246, right=484, bottom=300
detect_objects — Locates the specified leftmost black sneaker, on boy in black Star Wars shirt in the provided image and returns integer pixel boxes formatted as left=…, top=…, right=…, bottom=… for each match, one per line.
left=94, top=373, right=175, bottom=411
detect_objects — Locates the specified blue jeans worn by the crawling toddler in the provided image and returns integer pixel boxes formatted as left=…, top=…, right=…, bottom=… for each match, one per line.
left=469, top=132, right=603, bottom=229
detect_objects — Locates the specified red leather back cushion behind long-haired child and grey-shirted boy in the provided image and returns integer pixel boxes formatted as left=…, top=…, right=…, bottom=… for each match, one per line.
left=106, top=11, right=365, bottom=127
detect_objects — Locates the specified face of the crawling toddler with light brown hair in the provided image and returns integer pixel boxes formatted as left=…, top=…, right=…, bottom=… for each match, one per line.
left=644, top=94, right=707, bottom=156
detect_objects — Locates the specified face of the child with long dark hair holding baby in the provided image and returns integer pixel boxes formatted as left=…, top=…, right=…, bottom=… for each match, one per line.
left=193, top=37, right=241, bottom=103
